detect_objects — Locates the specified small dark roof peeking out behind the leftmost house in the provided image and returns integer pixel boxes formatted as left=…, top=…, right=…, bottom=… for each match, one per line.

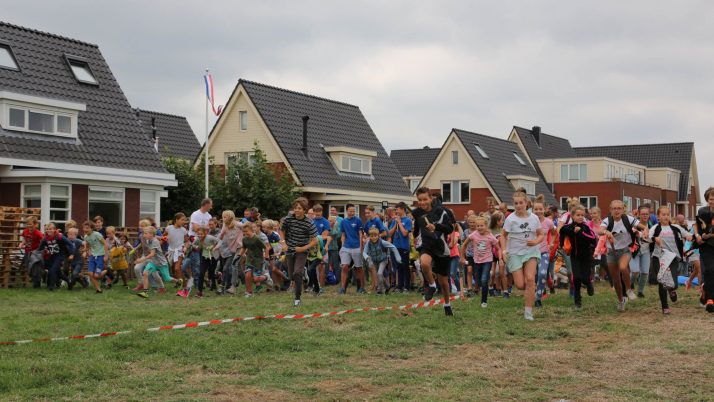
left=134, top=109, right=201, bottom=162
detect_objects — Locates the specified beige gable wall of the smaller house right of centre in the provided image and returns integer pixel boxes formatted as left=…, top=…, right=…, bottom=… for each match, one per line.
left=422, top=135, right=488, bottom=189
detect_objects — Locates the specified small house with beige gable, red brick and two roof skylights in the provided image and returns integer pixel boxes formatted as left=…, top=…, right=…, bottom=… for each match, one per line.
left=419, top=129, right=555, bottom=217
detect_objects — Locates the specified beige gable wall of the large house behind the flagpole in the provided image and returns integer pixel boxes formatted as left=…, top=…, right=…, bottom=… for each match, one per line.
left=204, top=89, right=284, bottom=165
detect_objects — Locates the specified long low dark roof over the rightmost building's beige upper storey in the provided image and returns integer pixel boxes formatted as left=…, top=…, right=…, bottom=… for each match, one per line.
left=574, top=142, right=694, bottom=201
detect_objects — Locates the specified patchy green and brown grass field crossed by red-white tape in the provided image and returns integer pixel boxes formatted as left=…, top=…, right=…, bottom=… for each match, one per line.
left=0, top=285, right=714, bottom=401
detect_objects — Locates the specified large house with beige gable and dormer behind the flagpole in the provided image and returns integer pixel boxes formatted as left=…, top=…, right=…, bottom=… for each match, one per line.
left=196, top=79, right=413, bottom=217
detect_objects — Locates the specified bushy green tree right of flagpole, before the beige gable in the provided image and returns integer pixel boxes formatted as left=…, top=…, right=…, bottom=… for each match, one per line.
left=209, top=143, right=300, bottom=219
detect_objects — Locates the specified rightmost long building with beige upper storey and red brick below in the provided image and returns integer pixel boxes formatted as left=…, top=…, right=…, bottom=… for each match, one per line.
left=509, top=126, right=699, bottom=218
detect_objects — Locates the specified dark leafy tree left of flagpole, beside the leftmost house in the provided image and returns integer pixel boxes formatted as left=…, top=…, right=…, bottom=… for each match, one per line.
left=161, top=156, right=205, bottom=221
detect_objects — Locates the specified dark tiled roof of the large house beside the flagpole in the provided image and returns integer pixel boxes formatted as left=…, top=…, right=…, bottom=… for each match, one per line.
left=214, top=79, right=411, bottom=197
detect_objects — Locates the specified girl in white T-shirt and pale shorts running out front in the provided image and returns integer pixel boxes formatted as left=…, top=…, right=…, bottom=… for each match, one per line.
left=500, top=192, right=544, bottom=321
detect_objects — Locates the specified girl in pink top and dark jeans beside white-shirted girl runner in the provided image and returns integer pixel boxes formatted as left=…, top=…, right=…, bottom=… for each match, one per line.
left=461, top=215, right=499, bottom=308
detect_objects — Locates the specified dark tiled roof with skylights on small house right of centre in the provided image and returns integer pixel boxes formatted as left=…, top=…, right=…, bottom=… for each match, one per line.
left=453, top=128, right=556, bottom=205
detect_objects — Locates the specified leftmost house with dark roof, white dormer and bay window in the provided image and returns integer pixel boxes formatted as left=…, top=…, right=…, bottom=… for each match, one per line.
left=0, top=22, right=176, bottom=226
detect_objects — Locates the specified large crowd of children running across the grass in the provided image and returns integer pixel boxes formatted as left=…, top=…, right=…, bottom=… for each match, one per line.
left=20, top=188, right=714, bottom=320
